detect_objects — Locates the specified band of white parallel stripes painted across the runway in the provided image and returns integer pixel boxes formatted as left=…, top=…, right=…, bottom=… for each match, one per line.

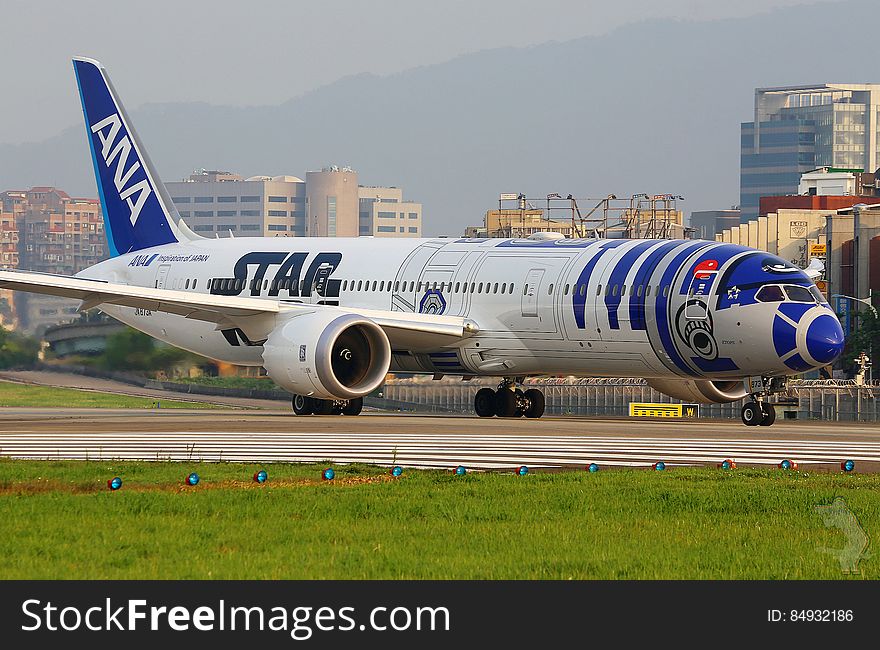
left=0, top=431, right=880, bottom=469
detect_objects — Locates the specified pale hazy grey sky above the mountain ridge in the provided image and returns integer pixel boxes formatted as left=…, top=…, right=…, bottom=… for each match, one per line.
left=0, top=0, right=828, bottom=143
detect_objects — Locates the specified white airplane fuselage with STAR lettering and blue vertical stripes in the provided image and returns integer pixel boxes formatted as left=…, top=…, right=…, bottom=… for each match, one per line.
left=80, top=237, right=840, bottom=379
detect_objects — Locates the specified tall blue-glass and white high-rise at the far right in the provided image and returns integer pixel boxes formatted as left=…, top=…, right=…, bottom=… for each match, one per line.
left=740, top=84, right=880, bottom=221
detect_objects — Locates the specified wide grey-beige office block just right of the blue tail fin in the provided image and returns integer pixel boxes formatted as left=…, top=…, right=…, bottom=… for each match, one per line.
left=165, top=171, right=306, bottom=237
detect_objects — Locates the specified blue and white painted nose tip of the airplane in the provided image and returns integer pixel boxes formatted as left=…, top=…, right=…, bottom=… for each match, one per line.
left=773, top=303, right=846, bottom=372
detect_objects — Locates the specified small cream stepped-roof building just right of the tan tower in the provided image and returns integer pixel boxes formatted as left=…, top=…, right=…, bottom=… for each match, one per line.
left=358, top=186, right=422, bottom=237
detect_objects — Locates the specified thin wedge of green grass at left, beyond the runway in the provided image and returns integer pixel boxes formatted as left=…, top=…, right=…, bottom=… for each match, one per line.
left=0, top=381, right=218, bottom=409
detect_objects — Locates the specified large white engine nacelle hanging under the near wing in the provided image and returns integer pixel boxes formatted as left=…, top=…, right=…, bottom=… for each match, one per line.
left=263, top=311, right=391, bottom=399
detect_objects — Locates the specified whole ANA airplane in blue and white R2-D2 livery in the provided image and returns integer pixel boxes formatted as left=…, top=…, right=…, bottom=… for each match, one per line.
left=0, top=57, right=845, bottom=426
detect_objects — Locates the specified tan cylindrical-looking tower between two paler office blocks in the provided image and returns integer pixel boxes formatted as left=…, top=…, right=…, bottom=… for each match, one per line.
left=306, top=165, right=359, bottom=237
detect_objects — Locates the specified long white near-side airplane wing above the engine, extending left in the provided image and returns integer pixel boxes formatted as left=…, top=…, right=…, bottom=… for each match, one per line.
left=0, top=270, right=478, bottom=349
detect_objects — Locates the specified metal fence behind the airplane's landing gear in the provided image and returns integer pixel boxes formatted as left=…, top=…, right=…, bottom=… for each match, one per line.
left=380, top=378, right=880, bottom=422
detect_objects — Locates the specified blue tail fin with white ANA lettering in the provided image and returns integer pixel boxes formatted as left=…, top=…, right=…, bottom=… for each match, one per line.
left=73, top=57, right=181, bottom=257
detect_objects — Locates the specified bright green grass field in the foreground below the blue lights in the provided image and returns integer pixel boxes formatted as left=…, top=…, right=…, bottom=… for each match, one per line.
left=0, top=460, right=880, bottom=579
